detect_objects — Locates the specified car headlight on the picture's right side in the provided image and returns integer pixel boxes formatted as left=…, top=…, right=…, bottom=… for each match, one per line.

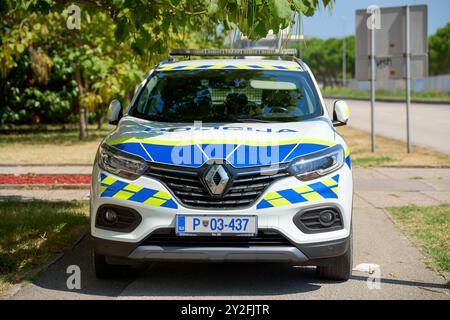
left=289, top=145, right=344, bottom=181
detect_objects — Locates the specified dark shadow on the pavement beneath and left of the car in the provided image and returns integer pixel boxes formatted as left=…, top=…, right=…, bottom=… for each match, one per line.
left=14, top=237, right=448, bottom=299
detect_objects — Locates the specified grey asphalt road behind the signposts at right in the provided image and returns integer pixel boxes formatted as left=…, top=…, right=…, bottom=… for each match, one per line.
left=326, top=100, right=450, bottom=154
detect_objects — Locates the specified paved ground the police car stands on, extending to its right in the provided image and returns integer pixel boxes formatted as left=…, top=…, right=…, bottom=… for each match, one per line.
left=7, top=168, right=450, bottom=300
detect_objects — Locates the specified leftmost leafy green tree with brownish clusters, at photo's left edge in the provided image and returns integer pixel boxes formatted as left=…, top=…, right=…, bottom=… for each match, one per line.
left=0, top=14, right=77, bottom=123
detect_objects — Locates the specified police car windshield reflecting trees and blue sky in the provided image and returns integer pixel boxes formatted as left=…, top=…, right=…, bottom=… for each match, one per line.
left=129, top=69, right=322, bottom=123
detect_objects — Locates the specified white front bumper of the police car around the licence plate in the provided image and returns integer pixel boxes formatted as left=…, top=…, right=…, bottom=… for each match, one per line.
left=90, top=161, right=353, bottom=263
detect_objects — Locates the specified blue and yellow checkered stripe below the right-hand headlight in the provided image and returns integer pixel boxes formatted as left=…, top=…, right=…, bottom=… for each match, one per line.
left=256, top=175, right=339, bottom=209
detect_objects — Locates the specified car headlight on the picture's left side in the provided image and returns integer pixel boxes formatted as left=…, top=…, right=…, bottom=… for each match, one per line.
left=97, top=143, right=148, bottom=180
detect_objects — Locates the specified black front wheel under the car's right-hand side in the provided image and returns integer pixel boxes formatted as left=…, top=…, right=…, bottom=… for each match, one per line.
left=317, top=232, right=353, bottom=281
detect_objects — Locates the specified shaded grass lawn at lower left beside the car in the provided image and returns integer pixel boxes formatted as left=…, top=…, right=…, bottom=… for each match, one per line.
left=0, top=201, right=89, bottom=295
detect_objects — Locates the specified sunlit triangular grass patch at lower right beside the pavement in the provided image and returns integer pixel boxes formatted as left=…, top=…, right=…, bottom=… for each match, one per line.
left=388, top=204, right=450, bottom=272
